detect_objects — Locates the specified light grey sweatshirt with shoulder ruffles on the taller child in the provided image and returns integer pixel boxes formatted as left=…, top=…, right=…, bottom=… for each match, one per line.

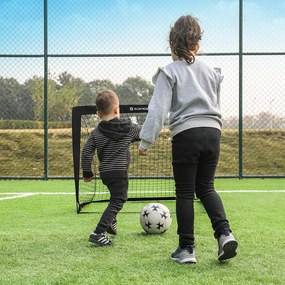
left=140, top=58, right=223, bottom=149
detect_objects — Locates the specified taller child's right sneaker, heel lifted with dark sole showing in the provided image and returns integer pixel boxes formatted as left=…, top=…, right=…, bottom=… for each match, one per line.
left=218, top=230, right=238, bottom=261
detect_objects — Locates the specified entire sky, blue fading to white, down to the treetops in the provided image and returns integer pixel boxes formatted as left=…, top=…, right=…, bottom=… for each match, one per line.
left=0, top=0, right=285, bottom=116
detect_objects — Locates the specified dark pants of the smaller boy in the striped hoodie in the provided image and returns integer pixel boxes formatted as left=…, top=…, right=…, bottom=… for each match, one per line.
left=95, top=178, right=129, bottom=233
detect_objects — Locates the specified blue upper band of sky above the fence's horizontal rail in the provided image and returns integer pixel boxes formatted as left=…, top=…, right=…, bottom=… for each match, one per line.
left=0, top=0, right=285, bottom=54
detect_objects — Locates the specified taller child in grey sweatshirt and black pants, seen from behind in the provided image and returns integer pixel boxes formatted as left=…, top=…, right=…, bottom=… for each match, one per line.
left=139, top=15, right=238, bottom=263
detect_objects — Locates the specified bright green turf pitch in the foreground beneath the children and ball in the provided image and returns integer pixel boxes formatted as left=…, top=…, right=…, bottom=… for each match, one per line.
left=0, top=179, right=285, bottom=285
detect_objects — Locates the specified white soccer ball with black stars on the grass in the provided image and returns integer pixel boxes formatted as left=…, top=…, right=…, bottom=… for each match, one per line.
left=140, top=203, right=172, bottom=234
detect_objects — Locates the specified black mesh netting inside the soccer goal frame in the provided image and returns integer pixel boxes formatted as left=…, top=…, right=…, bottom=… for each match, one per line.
left=75, top=106, right=175, bottom=208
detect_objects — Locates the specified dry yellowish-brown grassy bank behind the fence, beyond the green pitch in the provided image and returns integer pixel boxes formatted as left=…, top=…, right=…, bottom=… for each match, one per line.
left=0, top=129, right=285, bottom=177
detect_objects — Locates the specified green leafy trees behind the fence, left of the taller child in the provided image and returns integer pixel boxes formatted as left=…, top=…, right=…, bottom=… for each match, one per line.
left=0, top=72, right=153, bottom=121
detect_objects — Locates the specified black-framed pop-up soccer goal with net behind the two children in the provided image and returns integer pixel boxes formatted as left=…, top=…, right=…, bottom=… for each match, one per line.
left=72, top=105, right=175, bottom=213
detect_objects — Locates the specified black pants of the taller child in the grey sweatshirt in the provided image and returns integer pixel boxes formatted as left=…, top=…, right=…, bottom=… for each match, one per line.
left=172, top=128, right=229, bottom=247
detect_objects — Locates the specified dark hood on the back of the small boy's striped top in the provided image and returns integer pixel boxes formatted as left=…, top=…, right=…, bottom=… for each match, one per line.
left=98, top=118, right=132, bottom=140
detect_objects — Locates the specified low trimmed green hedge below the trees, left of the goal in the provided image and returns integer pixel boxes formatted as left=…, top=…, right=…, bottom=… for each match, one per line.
left=0, top=120, right=71, bottom=129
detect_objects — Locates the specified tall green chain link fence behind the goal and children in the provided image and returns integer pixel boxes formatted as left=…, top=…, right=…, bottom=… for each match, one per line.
left=0, top=0, right=285, bottom=179
